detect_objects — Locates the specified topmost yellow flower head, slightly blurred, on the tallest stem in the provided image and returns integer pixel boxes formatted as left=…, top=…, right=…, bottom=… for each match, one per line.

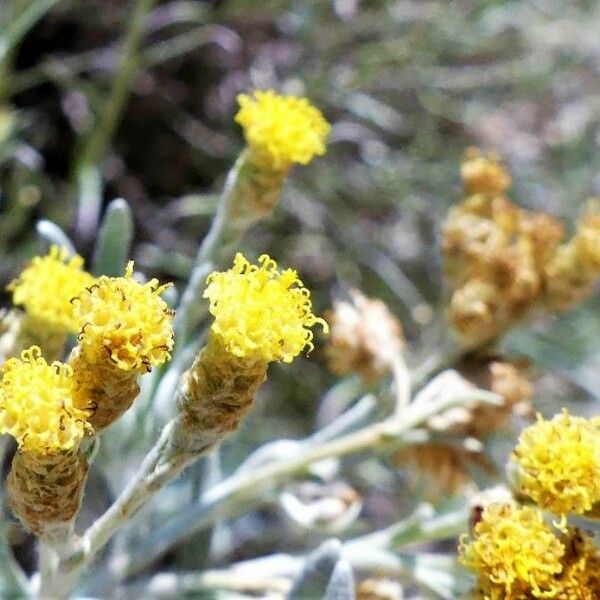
left=235, top=90, right=331, bottom=170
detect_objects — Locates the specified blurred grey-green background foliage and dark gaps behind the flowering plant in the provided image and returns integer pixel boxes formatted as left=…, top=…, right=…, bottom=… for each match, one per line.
left=0, top=0, right=600, bottom=592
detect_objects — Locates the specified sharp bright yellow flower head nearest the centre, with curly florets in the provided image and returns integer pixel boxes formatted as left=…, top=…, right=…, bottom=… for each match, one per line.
left=204, top=253, right=328, bottom=362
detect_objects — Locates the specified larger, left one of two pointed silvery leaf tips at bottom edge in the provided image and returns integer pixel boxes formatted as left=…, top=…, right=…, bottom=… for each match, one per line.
left=287, top=539, right=341, bottom=600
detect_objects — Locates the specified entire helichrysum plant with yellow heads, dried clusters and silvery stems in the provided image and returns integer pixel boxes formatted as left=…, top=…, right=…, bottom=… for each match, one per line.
left=0, top=83, right=600, bottom=600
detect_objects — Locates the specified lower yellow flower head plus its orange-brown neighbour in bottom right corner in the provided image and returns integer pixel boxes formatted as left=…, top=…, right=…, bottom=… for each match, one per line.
left=459, top=503, right=600, bottom=600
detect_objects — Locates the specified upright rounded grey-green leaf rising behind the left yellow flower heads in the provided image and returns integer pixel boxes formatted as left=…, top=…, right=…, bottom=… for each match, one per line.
left=93, top=198, right=133, bottom=276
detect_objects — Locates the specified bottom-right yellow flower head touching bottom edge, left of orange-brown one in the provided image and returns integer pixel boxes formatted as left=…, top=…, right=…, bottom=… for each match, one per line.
left=459, top=504, right=565, bottom=600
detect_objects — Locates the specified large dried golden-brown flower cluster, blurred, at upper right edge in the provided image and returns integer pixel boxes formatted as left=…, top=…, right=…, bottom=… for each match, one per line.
left=443, top=149, right=600, bottom=345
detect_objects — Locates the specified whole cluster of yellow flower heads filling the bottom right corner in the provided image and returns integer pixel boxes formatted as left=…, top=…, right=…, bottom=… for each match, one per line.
left=459, top=410, right=600, bottom=600
